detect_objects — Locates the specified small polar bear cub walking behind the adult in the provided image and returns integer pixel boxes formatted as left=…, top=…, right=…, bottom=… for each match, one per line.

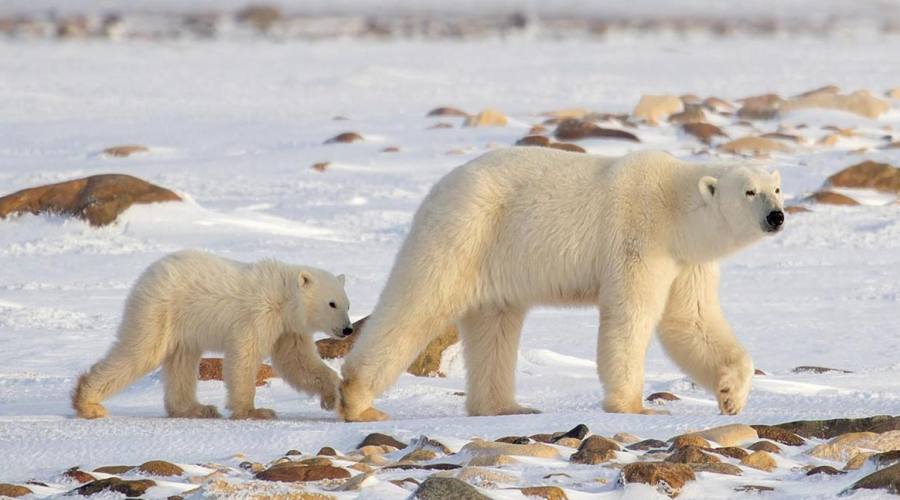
left=72, top=250, right=352, bottom=419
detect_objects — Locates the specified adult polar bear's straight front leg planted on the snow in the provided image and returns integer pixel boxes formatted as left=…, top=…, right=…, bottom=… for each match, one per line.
left=597, top=262, right=674, bottom=414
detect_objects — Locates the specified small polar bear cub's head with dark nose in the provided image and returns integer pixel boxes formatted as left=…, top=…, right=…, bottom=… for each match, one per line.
left=297, top=269, right=353, bottom=338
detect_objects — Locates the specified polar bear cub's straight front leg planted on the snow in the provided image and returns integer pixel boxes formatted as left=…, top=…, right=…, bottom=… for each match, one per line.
left=222, top=342, right=275, bottom=420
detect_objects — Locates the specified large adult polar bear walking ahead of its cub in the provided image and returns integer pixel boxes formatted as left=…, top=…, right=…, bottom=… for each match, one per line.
left=339, top=148, right=784, bottom=421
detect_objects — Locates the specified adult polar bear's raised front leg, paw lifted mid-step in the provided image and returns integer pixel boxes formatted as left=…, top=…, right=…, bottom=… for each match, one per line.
left=659, top=264, right=753, bottom=415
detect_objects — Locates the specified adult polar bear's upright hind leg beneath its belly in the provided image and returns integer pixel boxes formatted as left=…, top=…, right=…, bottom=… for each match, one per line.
left=459, top=307, right=540, bottom=415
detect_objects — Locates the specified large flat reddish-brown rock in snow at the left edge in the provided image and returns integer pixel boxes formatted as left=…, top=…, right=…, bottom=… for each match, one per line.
left=0, top=174, right=181, bottom=226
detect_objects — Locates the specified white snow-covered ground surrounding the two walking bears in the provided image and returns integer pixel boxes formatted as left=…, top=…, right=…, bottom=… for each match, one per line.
left=0, top=37, right=900, bottom=498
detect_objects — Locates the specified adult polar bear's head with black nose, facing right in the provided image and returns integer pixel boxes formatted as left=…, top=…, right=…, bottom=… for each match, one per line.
left=698, top=166, right=784, bottom=240
